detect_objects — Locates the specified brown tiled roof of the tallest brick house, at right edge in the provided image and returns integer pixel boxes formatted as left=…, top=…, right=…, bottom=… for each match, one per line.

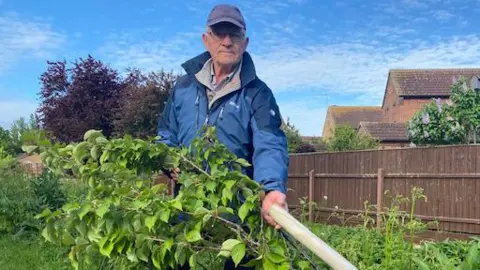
left=389, top=68, right=480, bottom=97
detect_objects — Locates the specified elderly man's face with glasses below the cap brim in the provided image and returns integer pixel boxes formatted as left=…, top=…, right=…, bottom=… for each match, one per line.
left=202, top=23, right=248, bottom=66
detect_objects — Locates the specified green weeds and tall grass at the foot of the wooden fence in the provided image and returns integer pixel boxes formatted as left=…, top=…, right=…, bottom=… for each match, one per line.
left=302, top=187, right=480, bottom=270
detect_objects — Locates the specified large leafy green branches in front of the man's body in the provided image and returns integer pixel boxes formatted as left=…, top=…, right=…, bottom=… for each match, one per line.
left=36, top=126, right=292, bottom=269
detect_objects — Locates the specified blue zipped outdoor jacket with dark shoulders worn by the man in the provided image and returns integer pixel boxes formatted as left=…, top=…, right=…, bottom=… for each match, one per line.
left=158, top=52, right=289, bottom=193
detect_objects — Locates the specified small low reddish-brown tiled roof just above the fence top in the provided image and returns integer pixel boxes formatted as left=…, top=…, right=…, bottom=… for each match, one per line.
left=359, top=122, right=409, bottom=142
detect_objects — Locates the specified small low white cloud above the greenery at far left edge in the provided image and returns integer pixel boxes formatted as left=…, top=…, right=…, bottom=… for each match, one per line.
left=0, top=100, right=38, bottom=129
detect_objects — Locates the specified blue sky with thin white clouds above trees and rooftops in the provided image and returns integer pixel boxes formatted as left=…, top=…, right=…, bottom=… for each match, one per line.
left=0, top=0, right=480, bottom=136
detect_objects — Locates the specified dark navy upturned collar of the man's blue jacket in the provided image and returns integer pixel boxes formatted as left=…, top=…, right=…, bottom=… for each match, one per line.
left=182, top=52, right=257, bottom=88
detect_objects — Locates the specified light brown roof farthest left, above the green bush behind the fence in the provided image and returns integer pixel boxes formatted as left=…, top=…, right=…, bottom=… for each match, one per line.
left=327, top=105, right=383, bottom=128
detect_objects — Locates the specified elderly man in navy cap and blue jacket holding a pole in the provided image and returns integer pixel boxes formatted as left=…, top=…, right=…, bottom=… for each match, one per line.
left=158, top=2, right=289, bottom=268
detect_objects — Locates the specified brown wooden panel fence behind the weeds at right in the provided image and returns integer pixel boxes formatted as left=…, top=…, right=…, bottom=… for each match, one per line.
left=288, top=145, right=480, bottom=239
